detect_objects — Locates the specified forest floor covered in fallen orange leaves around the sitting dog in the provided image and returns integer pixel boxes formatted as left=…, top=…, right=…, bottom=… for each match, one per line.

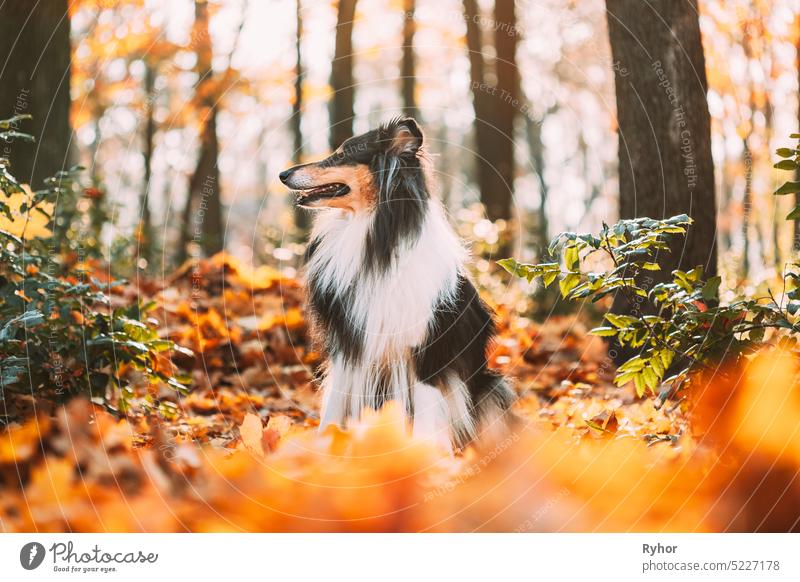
left=0, top=256, right=800, bottom=531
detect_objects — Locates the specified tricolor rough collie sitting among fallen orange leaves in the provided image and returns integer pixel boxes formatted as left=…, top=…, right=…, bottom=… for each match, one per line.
left=280, top=118, right=514, bottom=448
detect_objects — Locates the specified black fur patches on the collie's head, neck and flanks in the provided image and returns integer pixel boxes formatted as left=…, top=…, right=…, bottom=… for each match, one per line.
left=298, top=118, right=514, bottom=446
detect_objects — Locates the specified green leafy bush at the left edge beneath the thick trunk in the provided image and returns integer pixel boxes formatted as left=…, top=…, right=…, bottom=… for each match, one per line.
left=0, top=117, right=185, bottom=416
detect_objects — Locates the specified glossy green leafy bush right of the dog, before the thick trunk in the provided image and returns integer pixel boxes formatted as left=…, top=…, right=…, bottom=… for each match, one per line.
left=499, top=134, right=800, bottom=396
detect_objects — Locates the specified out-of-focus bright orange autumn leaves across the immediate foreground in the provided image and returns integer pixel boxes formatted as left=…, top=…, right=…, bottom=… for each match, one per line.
left=0, top=352, right=800, bottom=532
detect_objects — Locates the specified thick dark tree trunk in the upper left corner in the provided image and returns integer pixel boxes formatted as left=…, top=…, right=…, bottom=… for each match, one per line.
left=0, top=0, right=71, bottom=188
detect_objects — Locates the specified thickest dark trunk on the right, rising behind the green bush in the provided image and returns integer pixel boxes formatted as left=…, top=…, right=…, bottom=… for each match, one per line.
left=606, top=0, right=717, bottom=286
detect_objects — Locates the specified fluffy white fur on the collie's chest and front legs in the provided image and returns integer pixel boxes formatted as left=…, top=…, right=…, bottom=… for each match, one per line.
left=307, top=201, right=464, bottom=438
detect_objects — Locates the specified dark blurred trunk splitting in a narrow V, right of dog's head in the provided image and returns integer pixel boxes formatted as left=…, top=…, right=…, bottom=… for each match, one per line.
left=464, top=0, right=520, bottom=220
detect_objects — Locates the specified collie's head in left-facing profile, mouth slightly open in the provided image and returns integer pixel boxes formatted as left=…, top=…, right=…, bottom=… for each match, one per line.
left=280, top=117, right=423, bottom=212
